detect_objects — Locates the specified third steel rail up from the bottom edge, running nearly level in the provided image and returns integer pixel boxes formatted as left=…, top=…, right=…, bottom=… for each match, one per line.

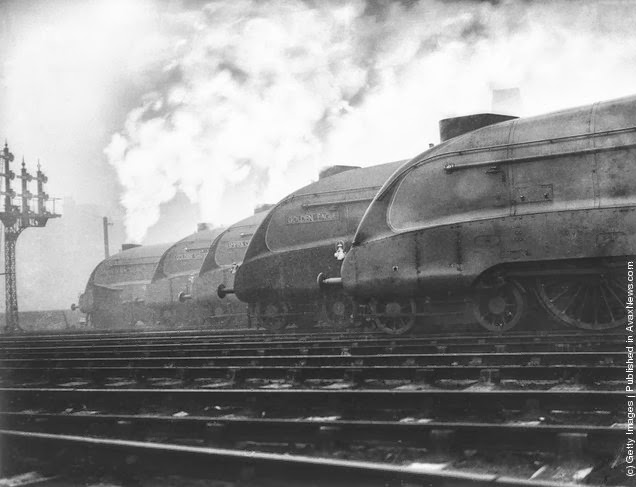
left=0, top=388, right=625, bottom=418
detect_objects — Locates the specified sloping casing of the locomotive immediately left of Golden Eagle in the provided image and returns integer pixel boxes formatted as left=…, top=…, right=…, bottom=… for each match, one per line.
left=192, top=211, right=267, bottom=324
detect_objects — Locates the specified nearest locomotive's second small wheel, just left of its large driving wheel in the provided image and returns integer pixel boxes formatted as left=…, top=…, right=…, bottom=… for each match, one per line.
left=473, top=281, right=527, bottom=332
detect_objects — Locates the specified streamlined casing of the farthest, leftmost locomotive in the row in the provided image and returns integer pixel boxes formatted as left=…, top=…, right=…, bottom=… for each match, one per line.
left=80, top=244, right=169, bottom=328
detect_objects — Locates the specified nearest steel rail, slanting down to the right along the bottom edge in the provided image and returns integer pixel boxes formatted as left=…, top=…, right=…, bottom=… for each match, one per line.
left=0, top=430, right=555, bottom=486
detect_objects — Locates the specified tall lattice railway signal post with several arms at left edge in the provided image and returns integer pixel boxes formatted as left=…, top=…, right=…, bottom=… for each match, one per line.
left=0, top=142, right=60, bottom=333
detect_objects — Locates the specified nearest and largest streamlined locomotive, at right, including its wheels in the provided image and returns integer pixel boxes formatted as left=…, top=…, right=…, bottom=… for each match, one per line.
left=340, top=97, right=636, bottom=332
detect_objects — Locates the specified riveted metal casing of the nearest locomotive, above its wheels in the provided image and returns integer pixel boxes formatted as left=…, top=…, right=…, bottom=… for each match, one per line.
left=342, top=97, right=636, bottom=298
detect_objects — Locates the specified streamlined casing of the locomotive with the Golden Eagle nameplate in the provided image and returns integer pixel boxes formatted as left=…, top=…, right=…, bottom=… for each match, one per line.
left=234, top=162, right=402, bottom=318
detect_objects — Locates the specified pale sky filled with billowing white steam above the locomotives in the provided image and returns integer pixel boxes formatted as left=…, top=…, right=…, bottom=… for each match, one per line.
left=0, top=0, right=636, bottom=242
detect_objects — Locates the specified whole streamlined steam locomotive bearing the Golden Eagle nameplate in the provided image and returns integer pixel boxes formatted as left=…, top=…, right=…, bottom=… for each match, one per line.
left=232, top=162, right=402, bottom=331
